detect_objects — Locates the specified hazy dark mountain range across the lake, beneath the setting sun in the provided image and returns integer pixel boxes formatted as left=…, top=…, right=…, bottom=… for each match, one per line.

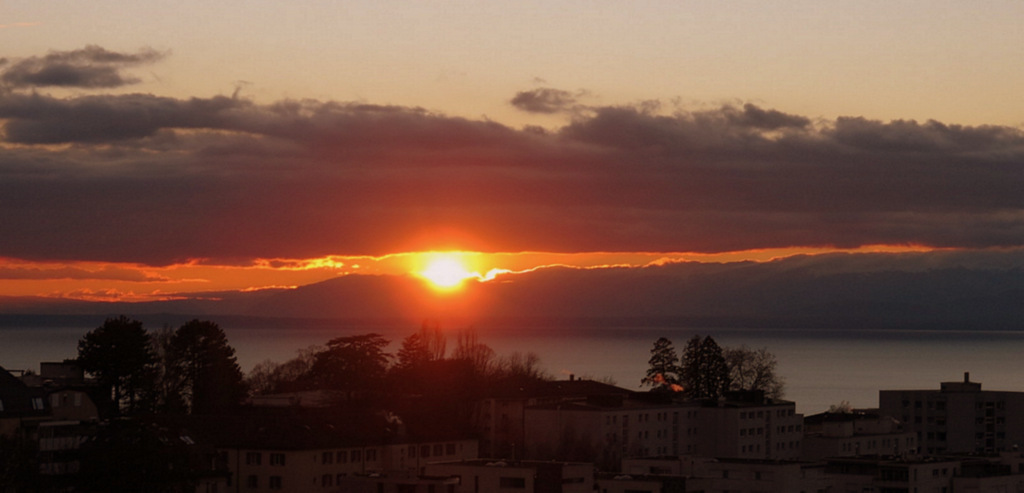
left=0, top=250, right=1024, bottom=330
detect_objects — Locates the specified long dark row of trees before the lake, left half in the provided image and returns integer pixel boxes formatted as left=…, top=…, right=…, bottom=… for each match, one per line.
left=73, top=316, right=551, bottom=415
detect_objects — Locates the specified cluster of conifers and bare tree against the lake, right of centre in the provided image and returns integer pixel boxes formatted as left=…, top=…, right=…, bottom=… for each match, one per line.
left=641, top=335, right=785, bottom=399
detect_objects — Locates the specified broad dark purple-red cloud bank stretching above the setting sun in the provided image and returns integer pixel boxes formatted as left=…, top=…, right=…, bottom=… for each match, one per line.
left=0, top=47, right=1024, bottom=264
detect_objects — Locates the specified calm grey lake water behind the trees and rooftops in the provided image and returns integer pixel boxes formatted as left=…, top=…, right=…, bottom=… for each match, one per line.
left=0, top=324, right=1024, bottom=414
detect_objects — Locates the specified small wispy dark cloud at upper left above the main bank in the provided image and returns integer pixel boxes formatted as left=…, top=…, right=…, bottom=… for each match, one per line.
left=0, top=45, right=165, bottom=89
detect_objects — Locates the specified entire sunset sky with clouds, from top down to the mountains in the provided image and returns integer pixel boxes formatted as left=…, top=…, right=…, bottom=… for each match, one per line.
left=0, top=0, right=1024, bottom=300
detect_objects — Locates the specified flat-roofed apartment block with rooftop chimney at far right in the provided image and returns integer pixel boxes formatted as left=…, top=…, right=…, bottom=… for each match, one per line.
left=879, top=373, right=1024, bottom=455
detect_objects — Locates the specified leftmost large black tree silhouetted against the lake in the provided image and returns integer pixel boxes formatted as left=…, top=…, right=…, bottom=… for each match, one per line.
left=77, top=315, right=157, bottom=414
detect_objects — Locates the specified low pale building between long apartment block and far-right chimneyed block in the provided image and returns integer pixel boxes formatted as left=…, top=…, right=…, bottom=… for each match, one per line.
left=802, top=411, right=918, bottom=460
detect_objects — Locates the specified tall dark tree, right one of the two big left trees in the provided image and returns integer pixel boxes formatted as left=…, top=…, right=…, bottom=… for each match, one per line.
left=167, top=320, right=248, bottom=414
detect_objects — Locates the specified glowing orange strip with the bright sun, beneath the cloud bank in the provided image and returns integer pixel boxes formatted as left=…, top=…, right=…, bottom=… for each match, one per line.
left=0, top=245, right=934, bottom=301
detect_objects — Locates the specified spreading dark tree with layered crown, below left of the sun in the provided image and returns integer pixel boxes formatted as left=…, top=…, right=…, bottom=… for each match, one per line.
left=309, top=334, right=391, bottom=392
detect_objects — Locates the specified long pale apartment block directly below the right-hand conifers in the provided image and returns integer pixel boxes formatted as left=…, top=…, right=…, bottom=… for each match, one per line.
left=524, top=392, right=803, bottom=470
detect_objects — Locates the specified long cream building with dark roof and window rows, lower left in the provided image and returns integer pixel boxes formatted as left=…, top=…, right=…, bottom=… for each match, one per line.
left=191, top=408, right=479, bottom=493
